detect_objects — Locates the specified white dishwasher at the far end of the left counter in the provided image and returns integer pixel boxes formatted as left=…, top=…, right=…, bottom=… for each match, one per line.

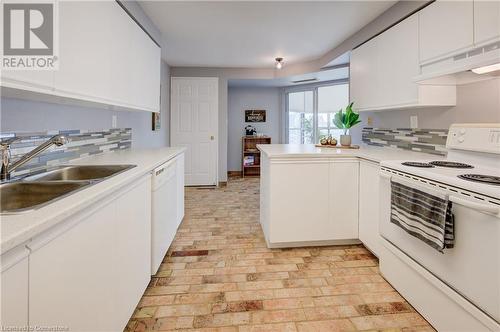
left=151, top=159, right=178, bottom=275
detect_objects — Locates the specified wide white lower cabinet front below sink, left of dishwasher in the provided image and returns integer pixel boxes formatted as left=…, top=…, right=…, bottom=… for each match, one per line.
left=29, top=176, right=151, bottom=331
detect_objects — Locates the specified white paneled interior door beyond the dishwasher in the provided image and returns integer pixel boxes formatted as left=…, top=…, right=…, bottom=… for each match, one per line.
left=170, top=77, right=219, bottom=186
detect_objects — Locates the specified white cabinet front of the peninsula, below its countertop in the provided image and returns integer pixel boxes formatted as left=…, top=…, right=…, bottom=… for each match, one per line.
left=261, top=157, right=359, bottom=247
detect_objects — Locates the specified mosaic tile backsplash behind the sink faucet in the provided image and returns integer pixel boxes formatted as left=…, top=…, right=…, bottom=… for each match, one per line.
left=0, top=128, right=132, bottom=176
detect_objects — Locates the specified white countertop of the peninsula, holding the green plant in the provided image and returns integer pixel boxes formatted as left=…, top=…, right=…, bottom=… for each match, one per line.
left=257, top=144, right=444, bottom=163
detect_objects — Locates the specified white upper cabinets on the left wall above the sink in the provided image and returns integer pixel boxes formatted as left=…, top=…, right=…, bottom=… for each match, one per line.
left=2, top=1, right=161, bottom=112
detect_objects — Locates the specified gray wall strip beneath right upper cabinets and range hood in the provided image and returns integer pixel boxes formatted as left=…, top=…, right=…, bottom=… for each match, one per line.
left=351, top=78, right=500, bottom=142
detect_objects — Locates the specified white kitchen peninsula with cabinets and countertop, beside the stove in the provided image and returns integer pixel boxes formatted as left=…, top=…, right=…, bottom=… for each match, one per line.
left=258, top=144, right=442, bottom=254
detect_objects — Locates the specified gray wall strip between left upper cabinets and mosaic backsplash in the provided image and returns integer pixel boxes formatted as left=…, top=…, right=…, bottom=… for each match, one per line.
left=0, top=62, right=170, bottom=148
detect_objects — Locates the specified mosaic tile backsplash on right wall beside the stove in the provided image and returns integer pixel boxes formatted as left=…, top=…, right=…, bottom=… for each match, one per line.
left=362, top=127, right=448, bottom=155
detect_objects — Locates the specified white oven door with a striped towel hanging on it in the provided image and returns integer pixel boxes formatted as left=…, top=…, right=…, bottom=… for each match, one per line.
left=379, top=170, right=500, bottom=322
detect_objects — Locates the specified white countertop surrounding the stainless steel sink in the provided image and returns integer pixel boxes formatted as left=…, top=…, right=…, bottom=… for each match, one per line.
left=0, top=148, right=185, bottom=253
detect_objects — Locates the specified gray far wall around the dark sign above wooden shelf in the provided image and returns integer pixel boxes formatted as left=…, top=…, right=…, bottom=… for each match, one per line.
left=227, top=88, right=281, bottom=171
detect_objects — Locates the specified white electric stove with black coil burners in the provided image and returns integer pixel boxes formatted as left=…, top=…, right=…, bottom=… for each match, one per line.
left=379, top=123, right=500, bottom=331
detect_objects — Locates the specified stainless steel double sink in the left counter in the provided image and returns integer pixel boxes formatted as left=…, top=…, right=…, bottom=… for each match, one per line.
left=0, top=165, right=136, bottom=213
